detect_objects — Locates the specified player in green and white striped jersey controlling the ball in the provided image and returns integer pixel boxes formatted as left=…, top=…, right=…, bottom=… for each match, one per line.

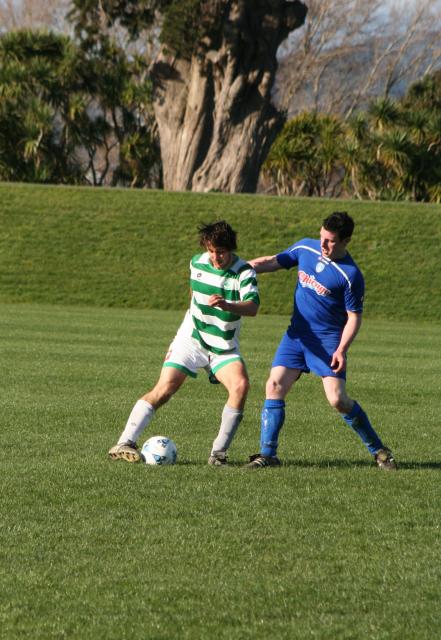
left=109, top=220, right=260, bottom=466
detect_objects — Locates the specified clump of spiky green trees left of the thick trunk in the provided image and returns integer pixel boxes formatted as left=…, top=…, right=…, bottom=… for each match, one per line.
left=0, top=30, right=160, bottom=186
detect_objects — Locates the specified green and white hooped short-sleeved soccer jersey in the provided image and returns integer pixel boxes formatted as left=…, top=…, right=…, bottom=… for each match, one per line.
left=190, top=253, right=260, bottom=354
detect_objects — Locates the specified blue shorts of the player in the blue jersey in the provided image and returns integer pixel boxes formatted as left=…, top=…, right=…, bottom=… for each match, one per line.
left=272, top=330, right=346, bottom=380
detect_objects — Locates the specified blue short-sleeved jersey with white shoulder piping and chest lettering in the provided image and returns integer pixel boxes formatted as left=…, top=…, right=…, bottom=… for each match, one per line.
left=277, top=238, right=364, bottom=338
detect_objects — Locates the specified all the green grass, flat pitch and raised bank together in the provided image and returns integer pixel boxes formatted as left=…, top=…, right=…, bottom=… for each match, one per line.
left=0, top=184, right=441, bottom=640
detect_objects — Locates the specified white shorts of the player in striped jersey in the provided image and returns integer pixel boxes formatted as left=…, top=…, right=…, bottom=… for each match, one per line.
left=163, top=318, right=243, bottom=378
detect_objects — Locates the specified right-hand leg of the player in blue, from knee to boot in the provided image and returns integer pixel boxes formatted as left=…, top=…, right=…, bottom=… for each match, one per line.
left=322, top=376, right=397, bottom=471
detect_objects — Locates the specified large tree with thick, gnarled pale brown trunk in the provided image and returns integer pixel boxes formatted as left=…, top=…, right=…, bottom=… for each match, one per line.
left=71, top=0, right=306, bottom=192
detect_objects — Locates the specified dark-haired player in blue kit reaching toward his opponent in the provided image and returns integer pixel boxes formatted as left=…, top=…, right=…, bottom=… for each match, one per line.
left=246, top=211, right=397, bottom=471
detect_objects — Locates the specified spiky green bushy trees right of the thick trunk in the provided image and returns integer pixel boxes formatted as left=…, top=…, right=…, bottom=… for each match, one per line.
left=263, top=73, right=441, bottom=202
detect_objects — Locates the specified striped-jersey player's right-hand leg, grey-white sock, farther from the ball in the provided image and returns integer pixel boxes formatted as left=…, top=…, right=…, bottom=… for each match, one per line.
left=208, top=360, right=250, bottom=466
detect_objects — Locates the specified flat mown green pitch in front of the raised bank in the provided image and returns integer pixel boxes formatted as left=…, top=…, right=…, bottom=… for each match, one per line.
left=0, top=304, right=441, bottom=640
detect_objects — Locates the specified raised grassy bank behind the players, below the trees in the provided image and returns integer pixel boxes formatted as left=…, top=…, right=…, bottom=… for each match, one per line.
left=0, top=184, right=441, bottom=320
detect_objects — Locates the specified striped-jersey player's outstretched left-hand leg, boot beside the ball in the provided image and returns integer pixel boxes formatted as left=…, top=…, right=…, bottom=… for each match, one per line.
left=109, top=367, right=187, bottom=462
